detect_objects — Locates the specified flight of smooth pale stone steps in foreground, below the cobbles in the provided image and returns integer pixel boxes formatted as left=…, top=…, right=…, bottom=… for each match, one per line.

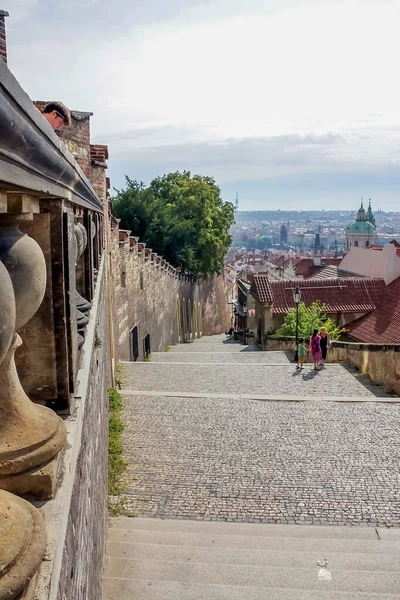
left=104, top=518, right=400, bottom=600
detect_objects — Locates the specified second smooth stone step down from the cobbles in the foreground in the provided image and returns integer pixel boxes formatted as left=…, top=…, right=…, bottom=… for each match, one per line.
left=108, top=525, right=400, bottom=558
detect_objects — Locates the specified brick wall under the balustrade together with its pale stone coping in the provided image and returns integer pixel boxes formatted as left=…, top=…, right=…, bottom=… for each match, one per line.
left=34, top=256, right=112, bottom=600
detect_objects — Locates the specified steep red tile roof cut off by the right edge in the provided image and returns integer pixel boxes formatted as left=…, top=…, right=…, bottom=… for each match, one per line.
left=348, top=277, right=400, bottom=344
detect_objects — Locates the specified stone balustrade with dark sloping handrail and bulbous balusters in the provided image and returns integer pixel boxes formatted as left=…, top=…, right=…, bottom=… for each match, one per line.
left=0, top=59, right=105, bottom=600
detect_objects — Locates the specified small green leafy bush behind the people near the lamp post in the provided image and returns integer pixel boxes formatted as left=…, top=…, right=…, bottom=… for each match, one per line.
left=275, top=301, right=346, bottom=340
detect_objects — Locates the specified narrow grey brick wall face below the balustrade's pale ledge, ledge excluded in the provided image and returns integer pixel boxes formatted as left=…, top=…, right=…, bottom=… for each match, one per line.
left=57, top=266, right=111, bottom=600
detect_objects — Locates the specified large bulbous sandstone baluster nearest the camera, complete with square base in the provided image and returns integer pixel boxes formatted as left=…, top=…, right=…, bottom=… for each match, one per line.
left=0, top=194, right=66, bottom=496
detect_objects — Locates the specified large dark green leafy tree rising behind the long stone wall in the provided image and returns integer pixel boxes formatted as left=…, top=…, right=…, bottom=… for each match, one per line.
left=112, top=171, right=234, bottom=276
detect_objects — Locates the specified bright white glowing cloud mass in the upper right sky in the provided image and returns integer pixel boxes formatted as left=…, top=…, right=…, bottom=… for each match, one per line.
left=93, top=2, right=400, bottom=137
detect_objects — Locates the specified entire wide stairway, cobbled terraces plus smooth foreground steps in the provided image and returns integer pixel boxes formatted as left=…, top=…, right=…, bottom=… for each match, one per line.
left=104, top=336, right=400, bottom=600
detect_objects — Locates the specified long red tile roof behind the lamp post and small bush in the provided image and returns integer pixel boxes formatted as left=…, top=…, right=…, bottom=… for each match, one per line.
left=252, top=273, right=385, bottom=314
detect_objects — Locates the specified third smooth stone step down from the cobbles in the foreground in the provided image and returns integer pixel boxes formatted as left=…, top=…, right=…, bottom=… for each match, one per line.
left=107, top=542, right=400, bottom=572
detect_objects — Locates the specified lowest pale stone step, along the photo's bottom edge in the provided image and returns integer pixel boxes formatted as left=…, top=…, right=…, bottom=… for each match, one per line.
left=104, top=578, right=400, bottom=600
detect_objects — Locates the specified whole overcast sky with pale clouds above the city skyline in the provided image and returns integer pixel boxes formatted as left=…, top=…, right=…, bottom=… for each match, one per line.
left=0, top=0, right=400, bottom=210
